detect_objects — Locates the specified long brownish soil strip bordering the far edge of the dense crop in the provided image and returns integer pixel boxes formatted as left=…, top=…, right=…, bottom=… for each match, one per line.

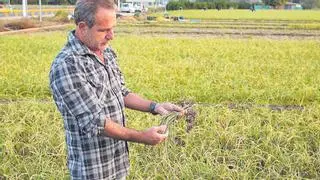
left=116, top=27, right=320, bottom=40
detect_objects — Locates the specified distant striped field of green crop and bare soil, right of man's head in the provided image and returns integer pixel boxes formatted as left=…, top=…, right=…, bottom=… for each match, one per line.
left=143, top=10, right=320, bottom=40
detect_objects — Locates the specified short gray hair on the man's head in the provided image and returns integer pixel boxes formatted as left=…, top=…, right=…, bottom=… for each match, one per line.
left=74, top=0, right=116, bottom=28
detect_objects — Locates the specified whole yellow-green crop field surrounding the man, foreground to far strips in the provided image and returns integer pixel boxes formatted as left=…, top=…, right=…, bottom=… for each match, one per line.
left=0, top=9, right=320, bottom=179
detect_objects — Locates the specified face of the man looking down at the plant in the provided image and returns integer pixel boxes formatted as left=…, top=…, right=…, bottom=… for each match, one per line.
left=83, top=8, right=116, bottom=51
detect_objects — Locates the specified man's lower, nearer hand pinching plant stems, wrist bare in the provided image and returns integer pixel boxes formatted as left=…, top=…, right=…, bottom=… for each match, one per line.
left=142, top=125, right=168, bottom=145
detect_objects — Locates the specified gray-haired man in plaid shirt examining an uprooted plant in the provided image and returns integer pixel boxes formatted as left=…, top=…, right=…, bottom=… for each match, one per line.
left=50, top=0, right=182, bottom=179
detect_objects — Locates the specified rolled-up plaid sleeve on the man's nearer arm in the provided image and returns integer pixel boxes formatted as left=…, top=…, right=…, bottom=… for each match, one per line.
left=50, top=61, right=108, bottom=137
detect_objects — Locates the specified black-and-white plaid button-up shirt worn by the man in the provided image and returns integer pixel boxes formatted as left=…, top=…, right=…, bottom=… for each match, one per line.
left=49, top=31, right=129, bottom=179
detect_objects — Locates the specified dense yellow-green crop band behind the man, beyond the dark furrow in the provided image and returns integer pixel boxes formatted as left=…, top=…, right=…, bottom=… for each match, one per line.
left=0, top=32, right=320, bottom=104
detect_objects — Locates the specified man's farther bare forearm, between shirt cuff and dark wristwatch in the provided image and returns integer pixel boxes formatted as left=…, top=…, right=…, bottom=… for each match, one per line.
left=124, top=93, right=152, bottom=112
